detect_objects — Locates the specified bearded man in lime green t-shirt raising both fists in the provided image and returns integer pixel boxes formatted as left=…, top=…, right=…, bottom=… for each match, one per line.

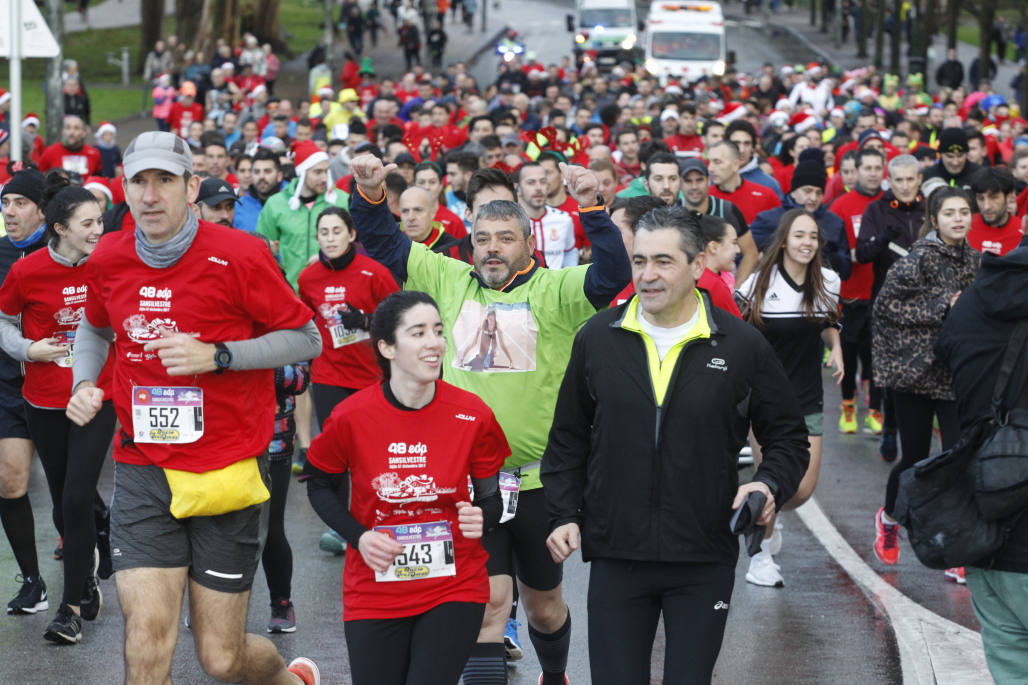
left=351, top=155, right=629, bottom=685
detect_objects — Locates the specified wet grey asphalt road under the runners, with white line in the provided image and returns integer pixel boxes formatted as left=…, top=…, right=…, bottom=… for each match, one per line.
left=0, top=6, right=988, bottom=685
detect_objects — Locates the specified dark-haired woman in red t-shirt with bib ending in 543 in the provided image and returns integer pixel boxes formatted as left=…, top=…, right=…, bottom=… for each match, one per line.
left=304, top=291, right=511, bottom=685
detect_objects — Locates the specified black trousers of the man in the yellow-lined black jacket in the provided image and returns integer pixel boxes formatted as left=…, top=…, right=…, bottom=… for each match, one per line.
left=588, top=558, right=735, bottom=685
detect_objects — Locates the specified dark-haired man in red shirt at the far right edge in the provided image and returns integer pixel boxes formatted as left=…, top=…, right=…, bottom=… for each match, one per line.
left=967, top=167, right=1024, bottom=256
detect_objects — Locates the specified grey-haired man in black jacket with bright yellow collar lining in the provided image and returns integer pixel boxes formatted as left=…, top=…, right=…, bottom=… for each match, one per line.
left=541, top=203, right=809, bottom=685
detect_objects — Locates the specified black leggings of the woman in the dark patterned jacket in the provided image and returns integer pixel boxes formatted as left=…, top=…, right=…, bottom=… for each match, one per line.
left=885, top=390, right=960, bottom=516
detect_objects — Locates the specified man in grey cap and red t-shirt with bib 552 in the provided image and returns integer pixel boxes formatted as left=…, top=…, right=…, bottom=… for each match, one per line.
left=68, top=132, right=321, bottom=685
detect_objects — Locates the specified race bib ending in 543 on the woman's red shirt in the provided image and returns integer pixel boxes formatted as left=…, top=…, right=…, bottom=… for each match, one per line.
left=375, top=520, right=456, bottom=583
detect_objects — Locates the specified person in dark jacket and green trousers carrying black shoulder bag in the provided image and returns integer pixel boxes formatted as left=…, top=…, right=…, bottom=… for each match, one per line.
left=935, top=239, right=1028, bottom=683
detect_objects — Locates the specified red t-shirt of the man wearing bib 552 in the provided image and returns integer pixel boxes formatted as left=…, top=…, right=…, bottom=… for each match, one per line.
left=85, top=221, right=314, bottom=473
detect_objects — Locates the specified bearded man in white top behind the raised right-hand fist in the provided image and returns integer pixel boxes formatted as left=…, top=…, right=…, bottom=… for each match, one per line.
left=517, top=161, right=578, bottom=268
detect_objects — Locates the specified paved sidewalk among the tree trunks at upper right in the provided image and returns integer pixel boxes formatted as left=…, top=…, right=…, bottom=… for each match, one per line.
left=760, top=6, right=1018, bottom=99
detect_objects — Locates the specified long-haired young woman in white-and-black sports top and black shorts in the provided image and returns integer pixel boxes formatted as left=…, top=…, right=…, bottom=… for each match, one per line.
left=739, top=209, right=843, bottom=587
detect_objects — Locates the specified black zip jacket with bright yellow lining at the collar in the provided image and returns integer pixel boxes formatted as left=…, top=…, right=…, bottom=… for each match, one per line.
left=541, top=293, right=810, bottom=566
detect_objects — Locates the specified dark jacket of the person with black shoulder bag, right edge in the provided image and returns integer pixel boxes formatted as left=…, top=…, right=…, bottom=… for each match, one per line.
left=935, top=239, right=1028, bottom=573
